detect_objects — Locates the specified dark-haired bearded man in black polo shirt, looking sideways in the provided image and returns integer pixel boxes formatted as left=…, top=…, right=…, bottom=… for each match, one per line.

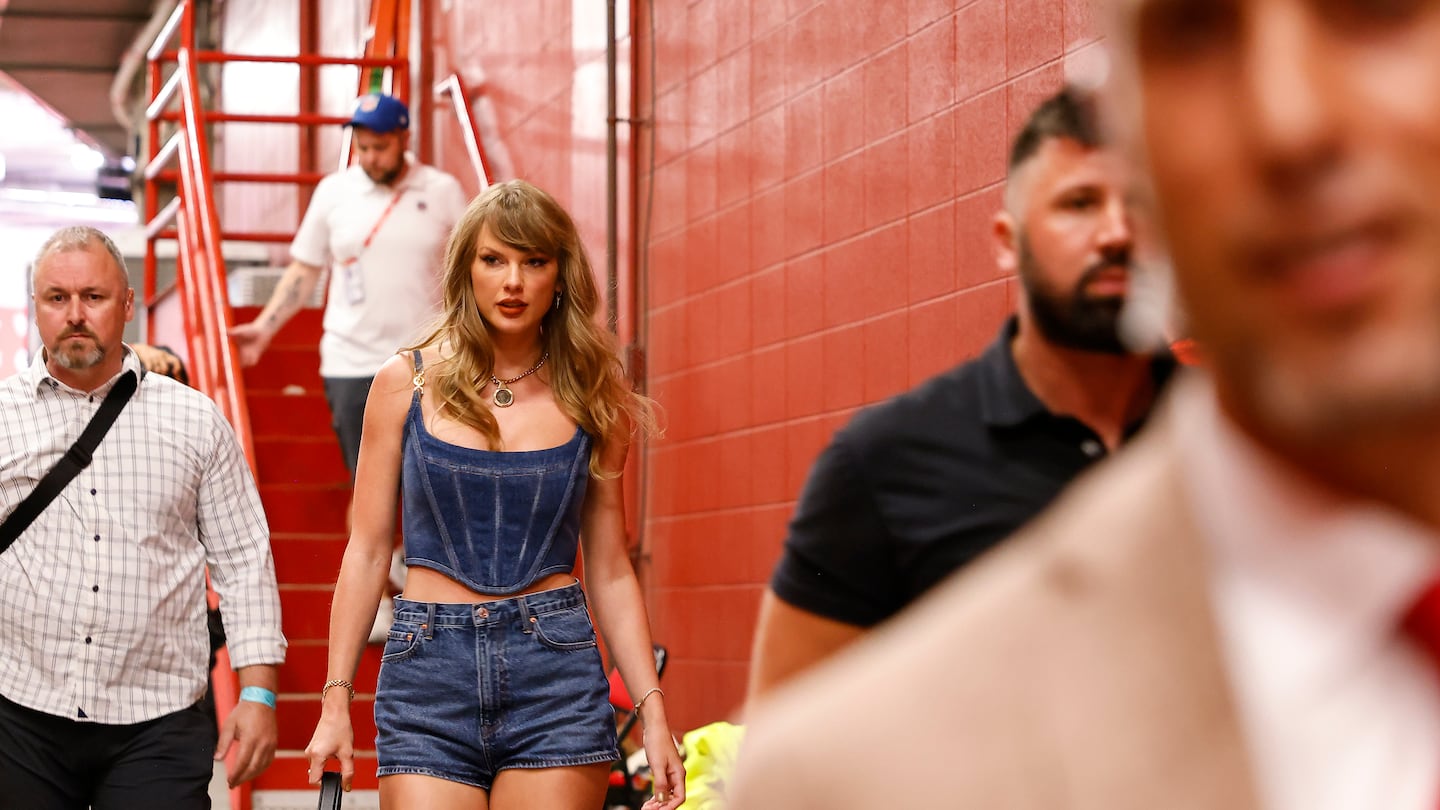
left=749, top=88, right=1174, bottom=698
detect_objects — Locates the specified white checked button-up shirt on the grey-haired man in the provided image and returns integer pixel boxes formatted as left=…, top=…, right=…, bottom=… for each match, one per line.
left=0, top=349, right=285, bottom=724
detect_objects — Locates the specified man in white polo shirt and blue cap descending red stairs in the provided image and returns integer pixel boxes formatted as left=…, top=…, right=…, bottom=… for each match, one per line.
left=230, top=94, right=465, bottom=477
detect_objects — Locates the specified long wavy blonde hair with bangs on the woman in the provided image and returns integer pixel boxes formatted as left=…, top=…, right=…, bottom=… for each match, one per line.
left=406, top=180, right=655, bottom=479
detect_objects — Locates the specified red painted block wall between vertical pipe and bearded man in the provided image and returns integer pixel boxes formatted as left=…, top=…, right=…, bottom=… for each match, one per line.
left=636, top=0, right=1094, bottom=729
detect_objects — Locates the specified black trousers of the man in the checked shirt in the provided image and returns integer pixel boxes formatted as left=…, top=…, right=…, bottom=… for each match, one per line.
left=0, top=686, right=217, bottom=810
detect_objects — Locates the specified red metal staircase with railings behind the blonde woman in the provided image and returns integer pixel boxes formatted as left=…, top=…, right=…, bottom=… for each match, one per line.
left=136, top=0, right=437, bottom=810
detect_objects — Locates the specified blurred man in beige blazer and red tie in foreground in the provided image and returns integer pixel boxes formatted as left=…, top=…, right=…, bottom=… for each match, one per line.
left=733, top=0, right=1440, bottom=810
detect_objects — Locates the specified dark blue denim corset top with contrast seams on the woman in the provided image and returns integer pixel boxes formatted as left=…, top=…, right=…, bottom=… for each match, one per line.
left=400, top=352, right=590, bottom=595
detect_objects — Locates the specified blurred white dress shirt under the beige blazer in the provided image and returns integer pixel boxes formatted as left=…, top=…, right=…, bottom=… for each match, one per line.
left=1174, top=378, right=1440, bottom=810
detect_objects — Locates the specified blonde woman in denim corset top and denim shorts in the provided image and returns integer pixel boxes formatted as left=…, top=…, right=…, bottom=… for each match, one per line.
left=307, top=180, right=685, bottom=810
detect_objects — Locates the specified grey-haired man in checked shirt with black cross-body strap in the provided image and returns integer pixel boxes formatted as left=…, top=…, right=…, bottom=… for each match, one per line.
left=0, top=226, right=285, bottom=810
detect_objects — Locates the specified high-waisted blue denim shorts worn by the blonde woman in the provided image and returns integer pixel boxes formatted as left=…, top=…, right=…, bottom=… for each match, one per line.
left=374, top=582, right=619, bottom=790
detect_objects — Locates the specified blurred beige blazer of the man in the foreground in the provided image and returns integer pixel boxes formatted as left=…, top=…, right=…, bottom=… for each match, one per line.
left=732, top=415, right=1259, bottom=810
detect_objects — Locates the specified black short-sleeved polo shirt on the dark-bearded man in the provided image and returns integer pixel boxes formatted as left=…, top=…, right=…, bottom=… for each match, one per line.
left=770, top=317, right=1175, bottom=627
